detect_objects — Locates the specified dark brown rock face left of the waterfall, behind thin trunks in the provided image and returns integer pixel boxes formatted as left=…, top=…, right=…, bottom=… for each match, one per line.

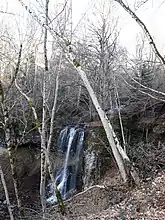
left=0, top=146, right=40, bottom=199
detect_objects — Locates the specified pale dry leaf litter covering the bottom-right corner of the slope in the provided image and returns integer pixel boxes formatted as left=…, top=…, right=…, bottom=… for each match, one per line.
left=85, top=172, right=165, bottom=220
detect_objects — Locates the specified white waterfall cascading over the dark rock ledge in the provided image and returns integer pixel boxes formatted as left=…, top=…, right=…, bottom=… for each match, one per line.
left=47, top=127, right=84, bottom=204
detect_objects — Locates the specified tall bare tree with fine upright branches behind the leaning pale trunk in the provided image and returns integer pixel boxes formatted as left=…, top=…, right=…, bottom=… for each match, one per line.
left=89, top=9, right=118, bottom=110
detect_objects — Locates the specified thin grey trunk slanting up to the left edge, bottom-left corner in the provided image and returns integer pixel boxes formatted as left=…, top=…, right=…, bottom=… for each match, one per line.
left=0, top=166, right=14, bottom=220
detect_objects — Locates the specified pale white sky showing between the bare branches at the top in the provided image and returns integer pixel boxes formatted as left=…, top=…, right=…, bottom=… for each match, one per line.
left=0, top=0, right=165, bottom=57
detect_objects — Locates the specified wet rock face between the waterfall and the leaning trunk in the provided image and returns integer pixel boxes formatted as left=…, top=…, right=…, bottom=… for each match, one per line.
left=83, top=126, right=117, bottom=189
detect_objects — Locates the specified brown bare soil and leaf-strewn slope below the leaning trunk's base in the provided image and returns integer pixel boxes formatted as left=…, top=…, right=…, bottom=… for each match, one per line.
left=47, top=172, right=165, bottom=220
